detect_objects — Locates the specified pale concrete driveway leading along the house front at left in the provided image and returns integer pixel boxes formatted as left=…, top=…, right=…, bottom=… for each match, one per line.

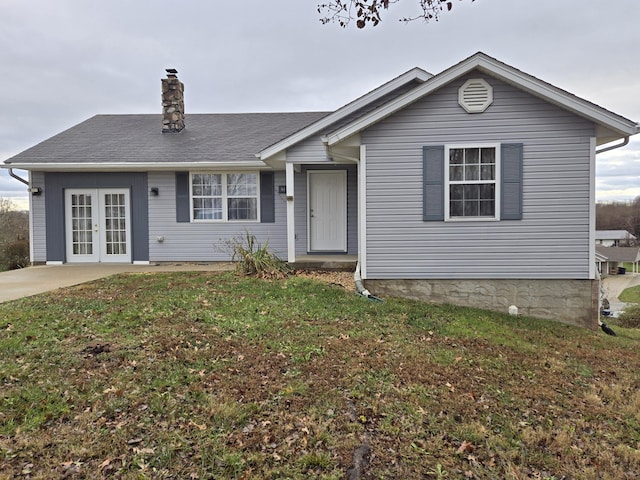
left=0, top=263, right=233, bottom=303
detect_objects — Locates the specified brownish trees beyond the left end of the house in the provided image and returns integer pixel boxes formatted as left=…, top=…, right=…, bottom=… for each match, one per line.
left=0, top=197, right=29, bottom=270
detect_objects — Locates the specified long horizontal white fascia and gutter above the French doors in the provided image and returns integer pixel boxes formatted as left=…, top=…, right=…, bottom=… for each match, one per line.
left=0, top=160, right=270, bottom=172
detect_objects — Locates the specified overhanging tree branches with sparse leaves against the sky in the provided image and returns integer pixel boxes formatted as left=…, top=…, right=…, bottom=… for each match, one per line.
left=318, top=0, right=475, bottom=28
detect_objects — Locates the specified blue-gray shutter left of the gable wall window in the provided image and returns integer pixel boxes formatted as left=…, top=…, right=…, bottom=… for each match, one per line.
left=422, top=145, right=444, bottom=222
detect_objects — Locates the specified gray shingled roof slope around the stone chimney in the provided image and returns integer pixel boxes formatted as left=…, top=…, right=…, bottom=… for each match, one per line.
left=5, top=112, right=328, bottom=165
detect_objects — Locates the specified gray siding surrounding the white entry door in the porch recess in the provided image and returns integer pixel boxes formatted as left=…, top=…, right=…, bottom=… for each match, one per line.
left=287, top=164, right=358, bottom=255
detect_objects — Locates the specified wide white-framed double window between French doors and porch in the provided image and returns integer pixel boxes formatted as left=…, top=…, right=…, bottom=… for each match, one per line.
left=191, top=172, right=260, bottom=221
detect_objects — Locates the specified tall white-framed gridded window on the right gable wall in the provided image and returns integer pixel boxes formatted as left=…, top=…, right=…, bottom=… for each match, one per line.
left=445, top=145, right=500, bottom=220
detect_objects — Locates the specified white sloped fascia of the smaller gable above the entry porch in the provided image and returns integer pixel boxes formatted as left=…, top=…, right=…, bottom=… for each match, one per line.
left=256, top=68, right=433, bottom=160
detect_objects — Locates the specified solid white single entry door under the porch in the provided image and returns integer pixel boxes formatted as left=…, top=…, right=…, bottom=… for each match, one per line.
left=307, top=170, right=347, bottom=252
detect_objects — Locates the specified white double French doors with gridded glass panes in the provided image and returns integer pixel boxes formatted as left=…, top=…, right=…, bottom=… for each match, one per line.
left=65, top=188, right=131, bottom=263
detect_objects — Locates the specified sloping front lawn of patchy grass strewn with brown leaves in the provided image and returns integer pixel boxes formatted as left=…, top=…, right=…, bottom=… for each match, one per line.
left=0, top=273, right=640, bottom=479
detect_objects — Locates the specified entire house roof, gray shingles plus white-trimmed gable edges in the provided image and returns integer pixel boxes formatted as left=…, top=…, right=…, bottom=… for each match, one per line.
left=5, top=52, right=640, bottom=169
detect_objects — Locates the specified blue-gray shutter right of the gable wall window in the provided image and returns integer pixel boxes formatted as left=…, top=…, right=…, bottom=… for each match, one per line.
left=500, top=143, right=523, bottom=220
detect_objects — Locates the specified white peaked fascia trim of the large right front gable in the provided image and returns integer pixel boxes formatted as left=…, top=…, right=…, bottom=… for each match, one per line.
left=326, top=54, right=640, bottom=146
